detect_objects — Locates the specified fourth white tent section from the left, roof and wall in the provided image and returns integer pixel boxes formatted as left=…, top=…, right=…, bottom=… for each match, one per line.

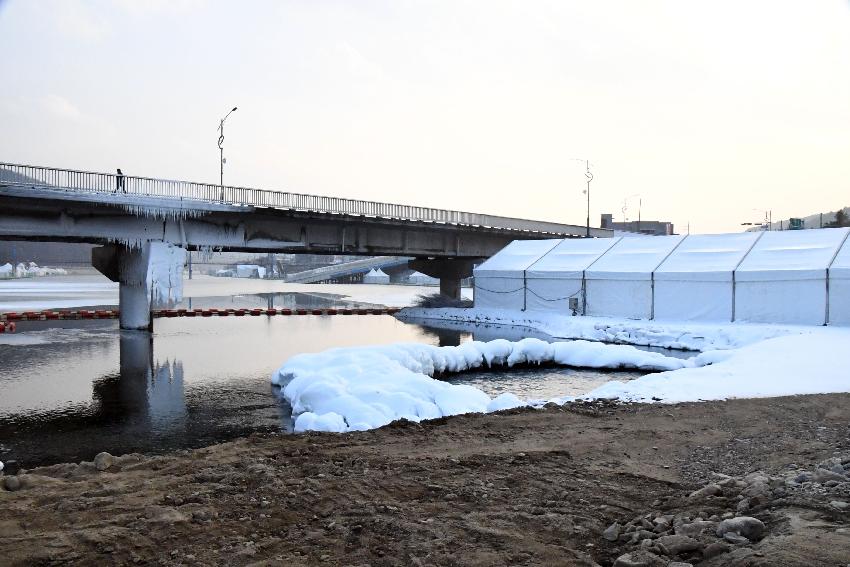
left=654, top=232, right=765, bottom=321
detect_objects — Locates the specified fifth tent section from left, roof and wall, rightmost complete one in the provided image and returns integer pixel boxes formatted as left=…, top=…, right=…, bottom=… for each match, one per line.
left=735, top=228, right=850, bottom=325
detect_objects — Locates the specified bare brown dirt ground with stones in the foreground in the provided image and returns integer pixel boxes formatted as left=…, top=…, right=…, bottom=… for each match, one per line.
left=0, top=394, right=850, bottom=567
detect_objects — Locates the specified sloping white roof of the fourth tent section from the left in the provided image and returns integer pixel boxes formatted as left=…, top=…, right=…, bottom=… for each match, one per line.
left=655, top=232, right=765, bottom=281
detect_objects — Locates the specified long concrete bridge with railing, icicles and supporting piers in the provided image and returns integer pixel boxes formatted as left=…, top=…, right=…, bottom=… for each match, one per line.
left=0, top=162, right=612, bottom=329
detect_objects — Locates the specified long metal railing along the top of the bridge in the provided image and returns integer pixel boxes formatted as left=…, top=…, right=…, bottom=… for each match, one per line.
left=0, top=162, right=612, bottom=236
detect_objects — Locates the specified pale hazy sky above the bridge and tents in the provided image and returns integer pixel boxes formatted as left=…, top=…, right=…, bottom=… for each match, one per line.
left=0, top=0, right=850, bottom=233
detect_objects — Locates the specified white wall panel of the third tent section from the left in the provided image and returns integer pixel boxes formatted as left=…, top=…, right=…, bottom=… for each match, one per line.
left=585, top=279, right=652, bottom=319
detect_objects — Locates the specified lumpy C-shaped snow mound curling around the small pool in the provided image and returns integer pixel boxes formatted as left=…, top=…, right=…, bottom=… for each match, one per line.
left=272, top=339, right=690, bottom=432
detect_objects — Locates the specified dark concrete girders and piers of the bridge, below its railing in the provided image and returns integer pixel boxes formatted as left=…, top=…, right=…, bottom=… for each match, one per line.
left=0, top=187, right=608, bottom=328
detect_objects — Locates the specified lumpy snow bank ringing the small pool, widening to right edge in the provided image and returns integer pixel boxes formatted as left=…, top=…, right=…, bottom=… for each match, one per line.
left=272, top=328, right=850, bottom=432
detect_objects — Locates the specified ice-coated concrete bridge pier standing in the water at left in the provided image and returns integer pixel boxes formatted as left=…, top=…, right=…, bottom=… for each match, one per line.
left=92, top=241, right=186, bottom=331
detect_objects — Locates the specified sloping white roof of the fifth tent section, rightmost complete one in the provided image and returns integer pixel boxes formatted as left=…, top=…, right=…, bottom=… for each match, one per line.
left=735, top=228, right=850, bottom=281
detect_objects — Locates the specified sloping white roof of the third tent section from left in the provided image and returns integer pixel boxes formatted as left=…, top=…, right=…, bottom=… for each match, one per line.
left=585, top=236, right=684, bottom=280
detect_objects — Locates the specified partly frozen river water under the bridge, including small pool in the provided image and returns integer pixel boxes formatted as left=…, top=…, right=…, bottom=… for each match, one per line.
left=0, top=276, right=672, bottom=467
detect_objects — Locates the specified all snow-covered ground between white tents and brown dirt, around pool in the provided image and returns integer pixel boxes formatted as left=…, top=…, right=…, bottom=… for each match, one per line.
left=272, top=309, right=850, bottom=432
